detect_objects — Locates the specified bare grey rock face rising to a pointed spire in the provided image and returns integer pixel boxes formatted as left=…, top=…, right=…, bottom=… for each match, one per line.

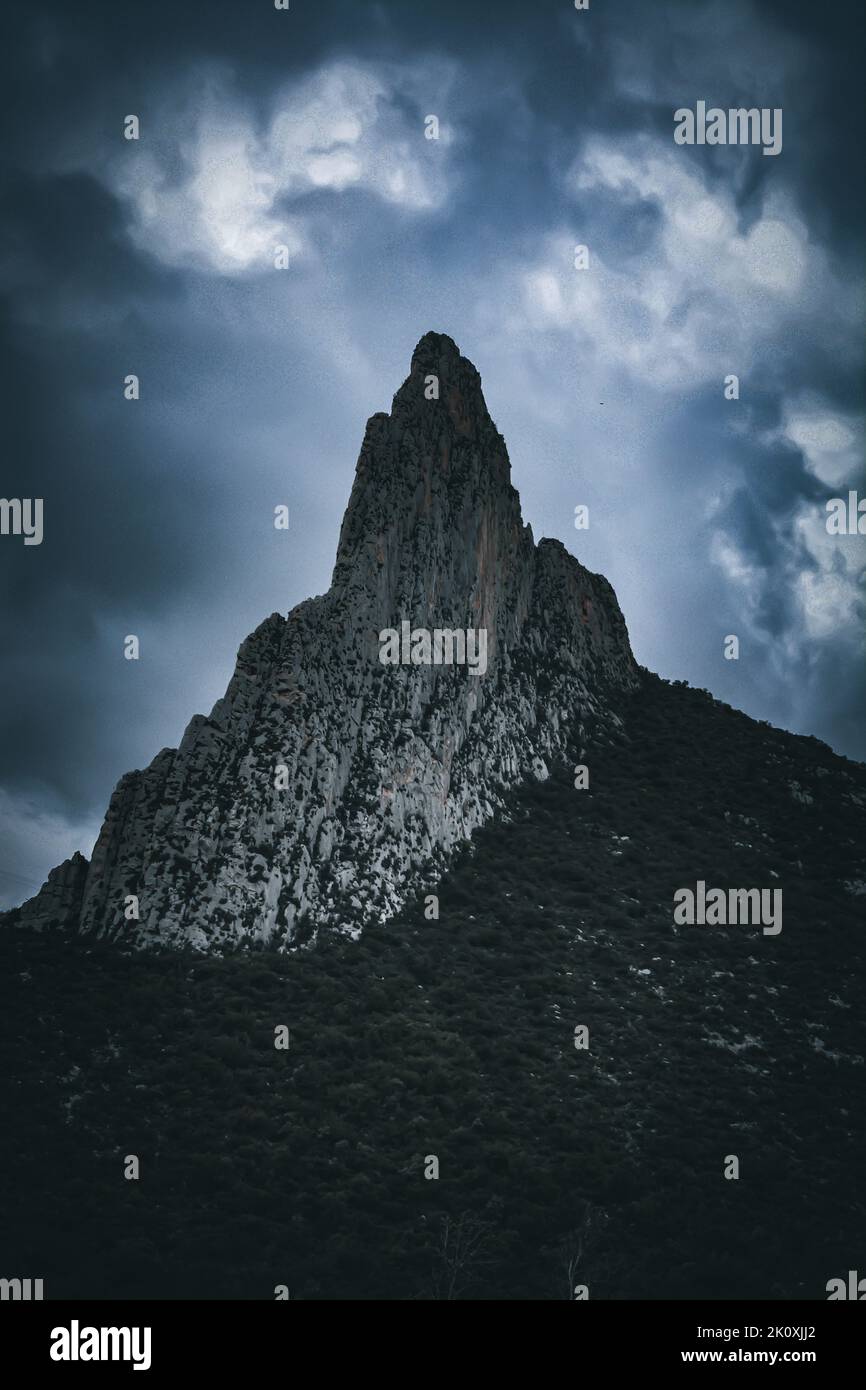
left=6, top=334, right=637, bottom=949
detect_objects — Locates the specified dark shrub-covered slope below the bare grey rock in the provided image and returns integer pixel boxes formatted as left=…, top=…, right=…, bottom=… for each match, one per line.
left=0, top=674, right=866, bottom=1298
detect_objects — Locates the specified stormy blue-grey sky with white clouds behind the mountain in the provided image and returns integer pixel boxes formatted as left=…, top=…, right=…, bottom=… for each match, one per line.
left=0, top=0, right=866, bottom=905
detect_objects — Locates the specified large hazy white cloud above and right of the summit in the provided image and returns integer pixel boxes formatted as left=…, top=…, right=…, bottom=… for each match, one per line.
left=523, top=136, right=859, bottom=391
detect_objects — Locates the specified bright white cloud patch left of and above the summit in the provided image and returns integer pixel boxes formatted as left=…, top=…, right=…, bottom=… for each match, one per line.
left=100, top=63, right=455, bottom=274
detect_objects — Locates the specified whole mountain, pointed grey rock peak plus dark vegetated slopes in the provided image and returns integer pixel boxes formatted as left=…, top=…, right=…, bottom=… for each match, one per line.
left=0, top=335, right=866, bottom=1295
